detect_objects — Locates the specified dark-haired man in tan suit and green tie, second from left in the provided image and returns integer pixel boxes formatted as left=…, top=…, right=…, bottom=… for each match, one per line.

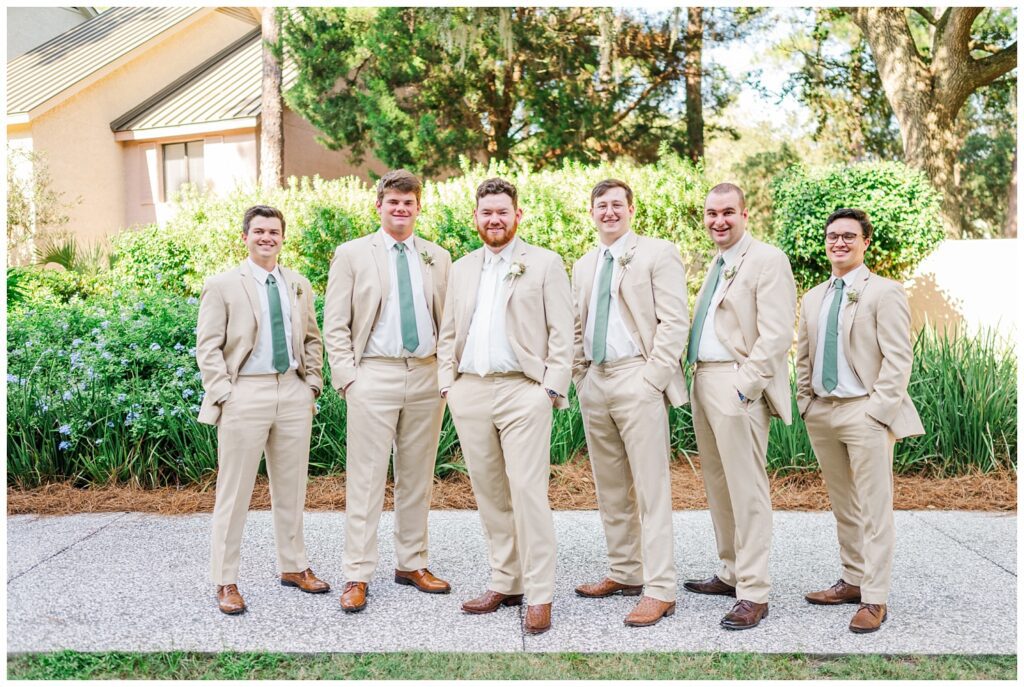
left=324, top=169, right=452, bottom=612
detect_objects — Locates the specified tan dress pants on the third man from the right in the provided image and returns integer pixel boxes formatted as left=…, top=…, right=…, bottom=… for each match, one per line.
left=577, top=357, right=676, bottom=602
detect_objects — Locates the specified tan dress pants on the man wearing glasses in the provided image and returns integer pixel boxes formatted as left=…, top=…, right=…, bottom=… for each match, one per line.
left=804, top=397, right=896, bottom=604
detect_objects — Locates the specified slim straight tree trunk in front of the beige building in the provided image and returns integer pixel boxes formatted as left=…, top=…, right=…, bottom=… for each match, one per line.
left=259, top=7, right=285, bottom=190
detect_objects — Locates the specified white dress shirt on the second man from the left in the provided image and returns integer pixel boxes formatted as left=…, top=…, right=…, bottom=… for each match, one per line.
left=362, top=228, right=437, bottom=357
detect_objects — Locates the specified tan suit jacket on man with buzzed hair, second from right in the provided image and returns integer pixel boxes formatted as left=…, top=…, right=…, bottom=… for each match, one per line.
left=697, top=237, right=797, bottom=425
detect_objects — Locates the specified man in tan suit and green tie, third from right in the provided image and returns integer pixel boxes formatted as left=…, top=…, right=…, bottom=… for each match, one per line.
left=572, top=179, right=689, bottom=627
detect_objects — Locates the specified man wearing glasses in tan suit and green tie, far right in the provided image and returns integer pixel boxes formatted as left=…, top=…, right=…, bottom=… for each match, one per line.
left=797, top=208, right=925, bottom=633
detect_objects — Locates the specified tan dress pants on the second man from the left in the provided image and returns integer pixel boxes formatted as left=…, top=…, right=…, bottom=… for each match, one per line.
left=342, top=357, right=444, bottom=582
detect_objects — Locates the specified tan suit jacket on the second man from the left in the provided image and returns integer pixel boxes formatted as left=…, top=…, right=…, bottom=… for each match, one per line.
left=324, top=231, right=452, bottom=393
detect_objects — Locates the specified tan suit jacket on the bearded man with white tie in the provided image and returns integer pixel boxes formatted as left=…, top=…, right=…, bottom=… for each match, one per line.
left=437, top=238, right=572, bottom=409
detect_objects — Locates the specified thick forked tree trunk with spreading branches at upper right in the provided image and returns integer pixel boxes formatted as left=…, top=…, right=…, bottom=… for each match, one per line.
left=846, top=7, right=1017, bottom=235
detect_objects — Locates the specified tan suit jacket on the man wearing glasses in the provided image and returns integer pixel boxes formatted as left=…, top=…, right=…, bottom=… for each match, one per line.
left=797, top=271, right=925, bottom=439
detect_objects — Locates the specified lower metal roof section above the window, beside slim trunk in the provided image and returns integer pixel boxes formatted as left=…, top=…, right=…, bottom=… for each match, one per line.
left=111, top=29, right=296, bottom=138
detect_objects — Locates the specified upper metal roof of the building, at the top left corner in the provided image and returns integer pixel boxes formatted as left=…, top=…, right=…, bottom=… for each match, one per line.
left=7, top=7, right=206, bottom=115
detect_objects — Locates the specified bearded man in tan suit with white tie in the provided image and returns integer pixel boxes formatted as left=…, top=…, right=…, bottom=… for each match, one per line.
left=437, top=179, right=572, bottom=634
